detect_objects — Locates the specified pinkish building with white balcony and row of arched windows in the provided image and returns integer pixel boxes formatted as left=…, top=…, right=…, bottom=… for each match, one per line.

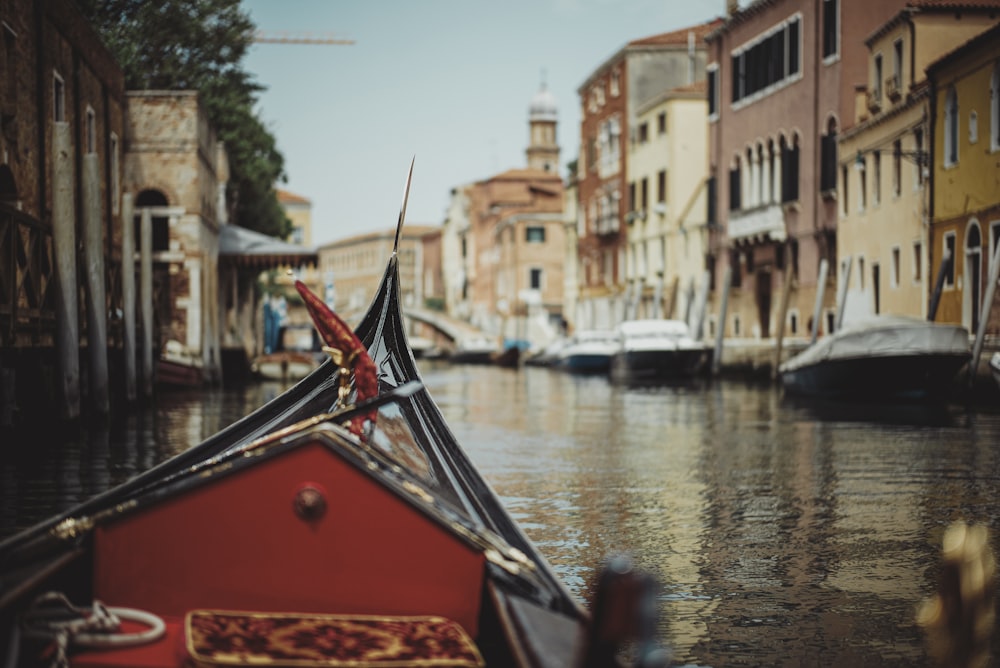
left=707, top=0, right=904, bottom=339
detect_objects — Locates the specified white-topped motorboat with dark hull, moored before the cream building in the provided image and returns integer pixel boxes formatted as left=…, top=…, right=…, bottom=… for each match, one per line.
left=609, top=318, right=710, bottom=384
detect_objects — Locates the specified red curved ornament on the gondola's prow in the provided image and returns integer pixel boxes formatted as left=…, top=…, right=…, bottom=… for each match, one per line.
left=295, top=279, right=378, bottom=436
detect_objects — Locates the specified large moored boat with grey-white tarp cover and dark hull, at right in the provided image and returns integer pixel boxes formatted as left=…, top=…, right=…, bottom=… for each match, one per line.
left=778, top=315, right=971, bottom=399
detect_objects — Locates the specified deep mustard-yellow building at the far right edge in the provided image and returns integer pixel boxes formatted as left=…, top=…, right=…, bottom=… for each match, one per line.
left=927, top=25, right=1000, bottom=338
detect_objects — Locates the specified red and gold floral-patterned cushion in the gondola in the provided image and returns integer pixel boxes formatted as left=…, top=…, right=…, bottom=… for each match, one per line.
left=184, top=610, right=484, bottom=668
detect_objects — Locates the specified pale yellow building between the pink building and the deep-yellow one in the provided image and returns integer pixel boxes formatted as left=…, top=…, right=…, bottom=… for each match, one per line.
left=831, top=5, right=994, bottom=322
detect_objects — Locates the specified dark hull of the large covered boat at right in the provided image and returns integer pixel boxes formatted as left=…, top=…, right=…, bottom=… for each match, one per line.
left=781, top=354, right=969, bottom=399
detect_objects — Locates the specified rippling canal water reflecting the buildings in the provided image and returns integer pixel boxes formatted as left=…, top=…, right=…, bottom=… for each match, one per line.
left=0, top=362, right=1000, bottom=666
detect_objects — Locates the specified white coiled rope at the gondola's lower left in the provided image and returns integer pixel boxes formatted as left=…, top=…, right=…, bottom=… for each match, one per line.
left=21, top=592, right=166, bottom=668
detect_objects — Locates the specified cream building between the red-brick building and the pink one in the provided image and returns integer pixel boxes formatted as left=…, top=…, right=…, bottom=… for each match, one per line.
left=625, top=80, right=708, bottom=328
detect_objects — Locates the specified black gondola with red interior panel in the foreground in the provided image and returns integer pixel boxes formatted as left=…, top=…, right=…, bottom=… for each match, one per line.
left=0, top=165, right=655, bottom=668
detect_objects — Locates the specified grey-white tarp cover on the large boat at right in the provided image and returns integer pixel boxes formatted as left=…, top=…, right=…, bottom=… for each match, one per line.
left=779, top=315, right=969, bottom=373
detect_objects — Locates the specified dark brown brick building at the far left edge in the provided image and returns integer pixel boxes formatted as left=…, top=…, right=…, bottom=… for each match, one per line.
left=0, top=0, right=125, bottom=417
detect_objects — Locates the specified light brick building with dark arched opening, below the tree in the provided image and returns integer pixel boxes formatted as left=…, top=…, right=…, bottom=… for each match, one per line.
left=125, top=91, right=229, bottom=382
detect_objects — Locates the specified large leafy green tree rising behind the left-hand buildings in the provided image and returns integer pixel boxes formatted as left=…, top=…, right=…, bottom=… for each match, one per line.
left=78, top=0, right=291, bottom=237
